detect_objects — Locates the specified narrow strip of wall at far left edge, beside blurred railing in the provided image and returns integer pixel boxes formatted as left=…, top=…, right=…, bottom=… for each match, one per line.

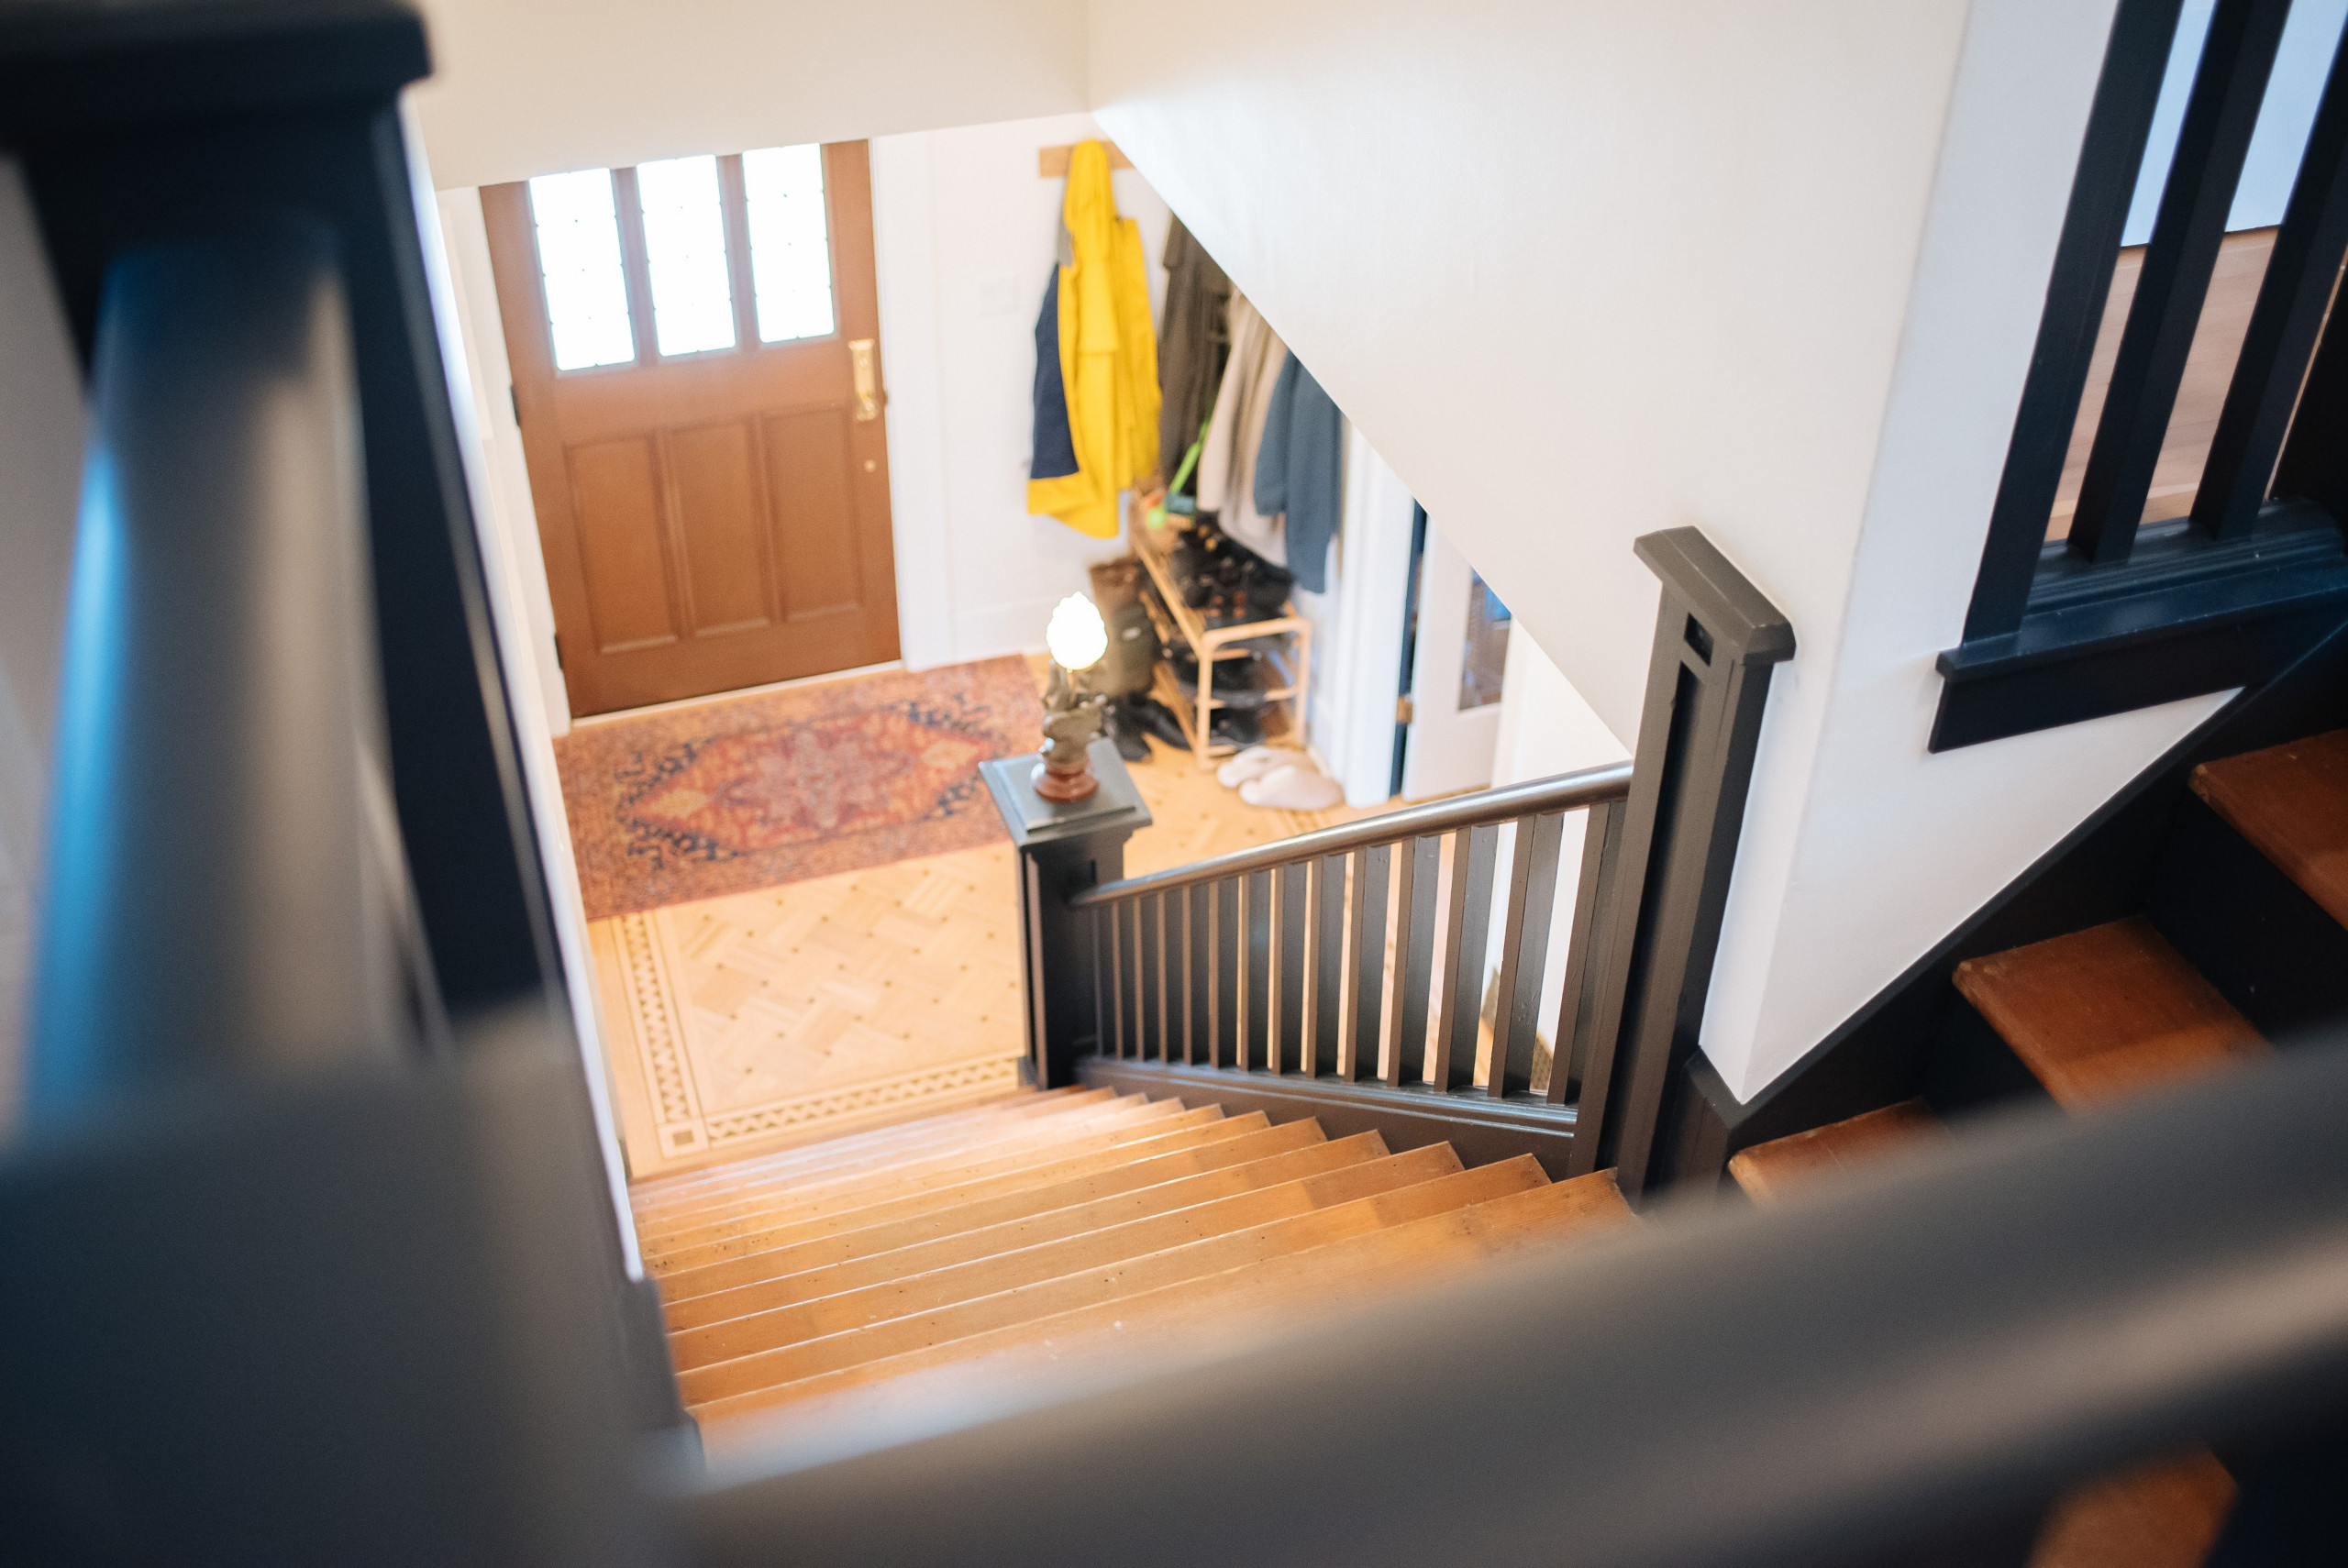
left=0, top=160, right=83, bottom=1129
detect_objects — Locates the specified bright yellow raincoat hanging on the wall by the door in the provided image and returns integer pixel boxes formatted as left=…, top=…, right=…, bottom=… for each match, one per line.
left=1028, top=141, right=1157, bottom=540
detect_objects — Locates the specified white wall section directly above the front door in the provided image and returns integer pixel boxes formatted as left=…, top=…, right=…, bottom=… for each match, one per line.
left=414, top=0, right=1085, bottom=190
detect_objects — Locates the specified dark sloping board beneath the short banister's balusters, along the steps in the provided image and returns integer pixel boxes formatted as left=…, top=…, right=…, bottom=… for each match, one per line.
left=1075, top=1056, right=1576, bottom=1181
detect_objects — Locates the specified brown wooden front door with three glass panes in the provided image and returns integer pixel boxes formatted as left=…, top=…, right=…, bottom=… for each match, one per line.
left=482, top=141, right=897, bottom=713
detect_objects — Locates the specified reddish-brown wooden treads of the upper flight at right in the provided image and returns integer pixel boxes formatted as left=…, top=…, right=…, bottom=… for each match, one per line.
left=1728, top=730, right=2348, bottom=1568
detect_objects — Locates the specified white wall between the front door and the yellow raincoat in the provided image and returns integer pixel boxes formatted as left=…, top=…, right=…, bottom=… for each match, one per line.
left=871, top=115, right=1167, bottom=669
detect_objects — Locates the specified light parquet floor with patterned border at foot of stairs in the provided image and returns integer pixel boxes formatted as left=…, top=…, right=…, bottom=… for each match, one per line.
left=590, top=661, right=1368, bottom=1178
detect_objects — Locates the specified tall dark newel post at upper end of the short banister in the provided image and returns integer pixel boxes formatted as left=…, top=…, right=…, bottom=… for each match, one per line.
left=1573, top=528, right=1794, bottom=1198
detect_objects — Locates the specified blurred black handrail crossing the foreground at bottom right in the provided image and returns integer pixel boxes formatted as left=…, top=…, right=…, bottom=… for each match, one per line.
left=686, top=1049, right=2348, bottom=1568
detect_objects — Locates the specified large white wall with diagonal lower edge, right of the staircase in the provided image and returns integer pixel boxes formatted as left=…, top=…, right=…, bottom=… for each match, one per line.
left=1091, top=0, right=2217, bottom=1096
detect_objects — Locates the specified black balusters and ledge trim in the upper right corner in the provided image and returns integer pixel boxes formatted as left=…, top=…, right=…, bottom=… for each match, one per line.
left=1930, top=0, right=2348, bottom=751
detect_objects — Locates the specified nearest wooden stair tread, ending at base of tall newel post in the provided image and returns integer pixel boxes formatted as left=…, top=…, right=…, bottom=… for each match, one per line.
left=692, top=1166, right=1634, bottom=1453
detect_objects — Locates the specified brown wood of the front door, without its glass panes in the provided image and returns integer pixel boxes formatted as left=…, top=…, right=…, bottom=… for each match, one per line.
left=482, top=143, right=897, bottom=713
